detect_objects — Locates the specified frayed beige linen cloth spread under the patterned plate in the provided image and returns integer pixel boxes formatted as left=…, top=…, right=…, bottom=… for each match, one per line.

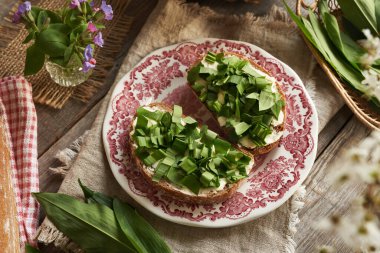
left=38, top=0, right=343, bottom=253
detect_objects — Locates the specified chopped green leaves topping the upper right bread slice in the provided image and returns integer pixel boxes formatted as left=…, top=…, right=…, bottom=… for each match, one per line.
left=187, top=52, right=285, bottom=147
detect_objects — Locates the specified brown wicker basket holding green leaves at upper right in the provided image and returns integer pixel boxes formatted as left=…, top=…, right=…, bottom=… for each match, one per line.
left=296, top=0, right=380, bottom=130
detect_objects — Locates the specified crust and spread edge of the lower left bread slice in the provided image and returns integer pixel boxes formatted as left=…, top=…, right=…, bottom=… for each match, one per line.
left=129, top=103, right=254, bottom=204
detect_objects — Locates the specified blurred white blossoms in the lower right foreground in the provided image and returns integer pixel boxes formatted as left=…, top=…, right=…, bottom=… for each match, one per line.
left=317, top=131, right=380, bottom=252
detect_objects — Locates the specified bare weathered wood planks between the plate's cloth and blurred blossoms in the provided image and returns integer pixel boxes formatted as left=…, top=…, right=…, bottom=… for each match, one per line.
left=295, top=117, right=370, bottom=253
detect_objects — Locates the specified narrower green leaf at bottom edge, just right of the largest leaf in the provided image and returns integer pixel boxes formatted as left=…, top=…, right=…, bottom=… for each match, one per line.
left=113, top=199, right=171, bottom=253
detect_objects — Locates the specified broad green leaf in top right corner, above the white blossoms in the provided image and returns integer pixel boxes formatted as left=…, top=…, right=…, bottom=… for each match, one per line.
left=338, top=0, right=379, bottom=35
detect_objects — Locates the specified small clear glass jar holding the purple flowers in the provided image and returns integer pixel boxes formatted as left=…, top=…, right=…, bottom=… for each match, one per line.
left=45, top=57, right=92, bottom=87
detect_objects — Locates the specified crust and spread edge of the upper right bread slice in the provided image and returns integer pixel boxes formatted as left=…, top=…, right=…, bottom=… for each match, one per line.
left=188, top=52, right=287, bottom=155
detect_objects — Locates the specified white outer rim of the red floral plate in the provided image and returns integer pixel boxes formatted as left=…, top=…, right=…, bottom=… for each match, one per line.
left=102, top=38, right=319, bottom=228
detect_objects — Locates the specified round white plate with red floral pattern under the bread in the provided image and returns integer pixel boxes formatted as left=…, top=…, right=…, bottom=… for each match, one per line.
left=103, top=39, right=318, bottom=227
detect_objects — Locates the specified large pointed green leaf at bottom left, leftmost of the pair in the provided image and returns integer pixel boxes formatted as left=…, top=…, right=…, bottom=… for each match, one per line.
left=33, top=193, right=136, bottom=253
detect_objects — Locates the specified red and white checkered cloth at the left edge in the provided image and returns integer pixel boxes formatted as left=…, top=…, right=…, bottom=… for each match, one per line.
left=0, top=77, right=39, bottom=244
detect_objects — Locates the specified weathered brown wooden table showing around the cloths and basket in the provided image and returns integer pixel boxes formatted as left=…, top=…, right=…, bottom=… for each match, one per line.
left=0, top=0, right=370, bottom=252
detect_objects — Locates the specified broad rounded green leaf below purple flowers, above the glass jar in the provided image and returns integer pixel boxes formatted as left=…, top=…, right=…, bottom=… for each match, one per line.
left=36, top=28, right=69, bottom=57
